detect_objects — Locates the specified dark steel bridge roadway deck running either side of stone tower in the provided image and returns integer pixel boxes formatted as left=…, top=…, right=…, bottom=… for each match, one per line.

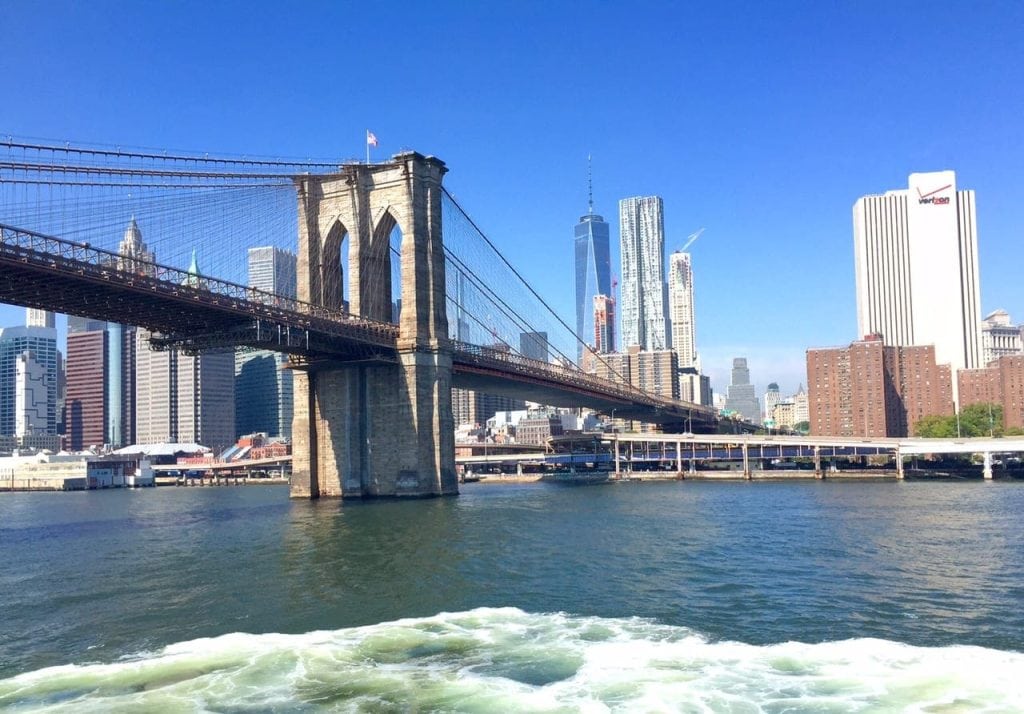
left=0, top=224, right=717, bottom=430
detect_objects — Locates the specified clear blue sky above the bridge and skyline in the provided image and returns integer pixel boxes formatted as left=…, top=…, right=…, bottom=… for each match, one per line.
left=0, top=2, right=1024, bottom=392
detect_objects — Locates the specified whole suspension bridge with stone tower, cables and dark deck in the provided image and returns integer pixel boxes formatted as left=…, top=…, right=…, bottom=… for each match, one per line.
left=0, top=139, right=716, bottom=498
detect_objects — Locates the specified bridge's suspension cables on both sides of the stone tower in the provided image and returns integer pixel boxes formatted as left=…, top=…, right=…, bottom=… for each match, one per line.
left=0, top=137, right=696, bottom=411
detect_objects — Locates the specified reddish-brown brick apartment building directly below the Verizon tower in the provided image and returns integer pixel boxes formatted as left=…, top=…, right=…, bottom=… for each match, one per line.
left=807, top=335, right=953, bottom=436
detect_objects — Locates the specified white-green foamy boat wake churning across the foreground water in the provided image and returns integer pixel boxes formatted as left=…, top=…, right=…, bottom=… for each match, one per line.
left=0, top=608, right=1024, bottom=713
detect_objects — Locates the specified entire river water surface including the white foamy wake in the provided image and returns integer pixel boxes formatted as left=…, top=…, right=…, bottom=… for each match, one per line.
left=0, top=481, right=1024, bottom=712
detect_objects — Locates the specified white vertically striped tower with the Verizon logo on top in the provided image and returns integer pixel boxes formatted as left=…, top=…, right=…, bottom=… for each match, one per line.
left=853, top=171, right=981, bottom=379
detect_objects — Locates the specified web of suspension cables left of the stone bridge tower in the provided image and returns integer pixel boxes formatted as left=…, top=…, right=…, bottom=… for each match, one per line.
left=0, top=137, right=303, bottom=283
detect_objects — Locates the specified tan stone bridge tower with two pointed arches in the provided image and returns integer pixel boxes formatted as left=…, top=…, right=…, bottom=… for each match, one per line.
left=292, top=152, right=459, bottom=498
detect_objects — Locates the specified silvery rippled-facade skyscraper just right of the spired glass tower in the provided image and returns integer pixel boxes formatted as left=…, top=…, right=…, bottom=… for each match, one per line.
left=618, top=196, right=670, bottom=350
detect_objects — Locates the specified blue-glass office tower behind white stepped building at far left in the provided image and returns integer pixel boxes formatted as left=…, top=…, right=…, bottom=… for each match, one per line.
left=0, top=327, right=57, bottom=436
